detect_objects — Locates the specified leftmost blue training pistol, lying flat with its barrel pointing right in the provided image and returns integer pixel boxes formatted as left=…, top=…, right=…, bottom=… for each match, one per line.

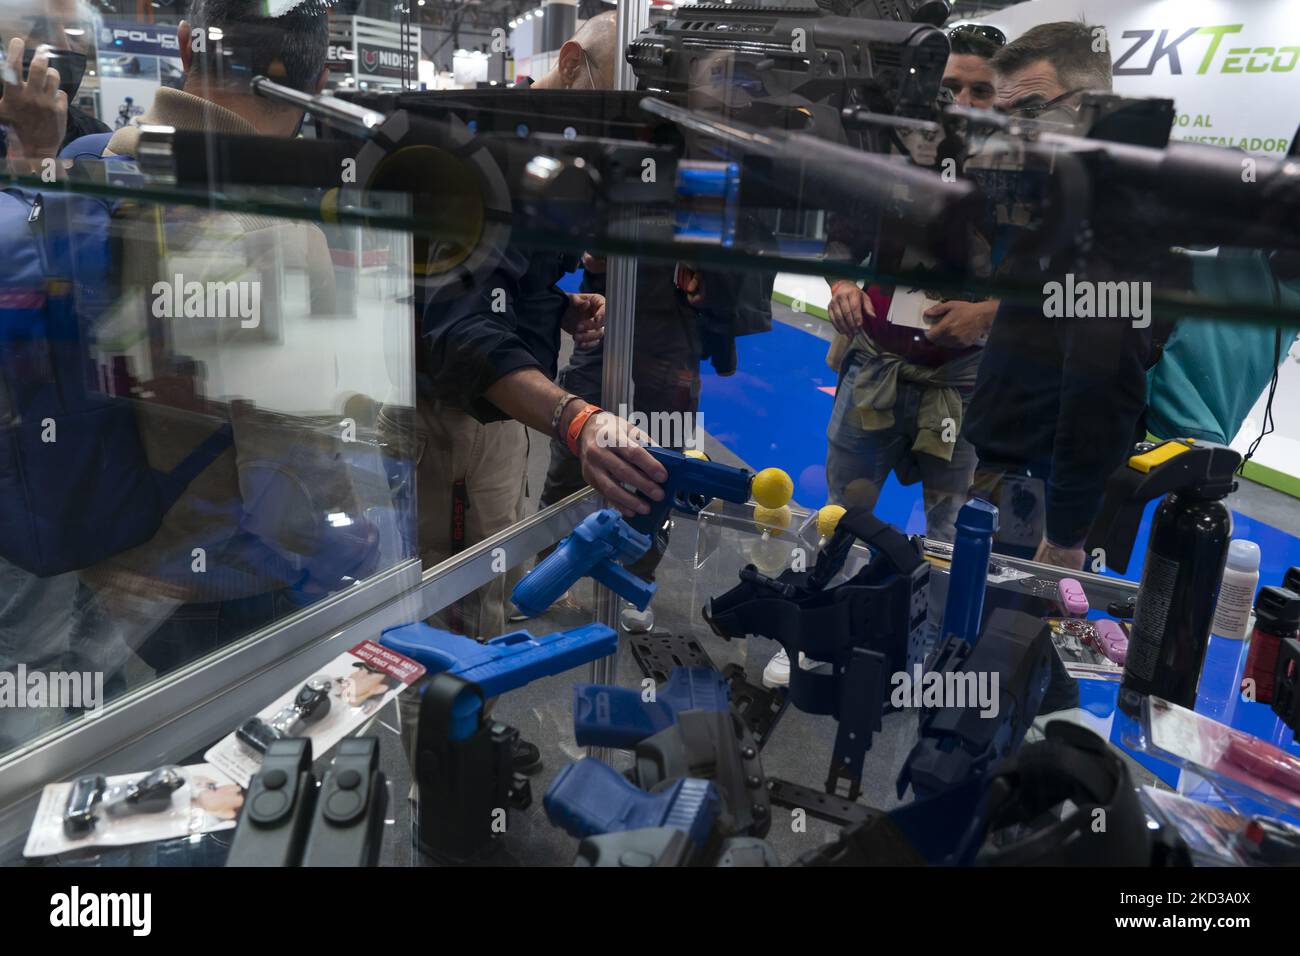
left=380, top=623, right=619, bottom=740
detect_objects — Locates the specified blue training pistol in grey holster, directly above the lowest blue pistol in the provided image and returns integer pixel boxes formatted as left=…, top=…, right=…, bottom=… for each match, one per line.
left=573, top=667, right=731, bottom=749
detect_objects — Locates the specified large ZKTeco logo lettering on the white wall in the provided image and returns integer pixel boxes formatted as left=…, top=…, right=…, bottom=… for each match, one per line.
left=1112, top=23, right=1300, bottom=77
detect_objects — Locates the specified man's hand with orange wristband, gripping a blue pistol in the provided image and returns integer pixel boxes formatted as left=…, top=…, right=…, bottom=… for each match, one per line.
left=564, top=402, right=668, bottom=518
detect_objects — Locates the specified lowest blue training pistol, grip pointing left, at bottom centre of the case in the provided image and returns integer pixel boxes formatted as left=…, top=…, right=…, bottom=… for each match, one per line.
left=542, top=757, right=720, bottom=847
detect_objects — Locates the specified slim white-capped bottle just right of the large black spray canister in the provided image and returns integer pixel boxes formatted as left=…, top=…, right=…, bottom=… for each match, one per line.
left=1196, top=538, right=1260, bottom=723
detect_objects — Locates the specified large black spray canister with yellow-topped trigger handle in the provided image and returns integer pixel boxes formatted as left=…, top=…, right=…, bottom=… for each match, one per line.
left=1086, top=438, right=1242, bottom=717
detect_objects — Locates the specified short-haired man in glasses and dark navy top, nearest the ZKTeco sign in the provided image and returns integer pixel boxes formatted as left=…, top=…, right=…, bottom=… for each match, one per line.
left=963, top=22, right=1152, bottom=570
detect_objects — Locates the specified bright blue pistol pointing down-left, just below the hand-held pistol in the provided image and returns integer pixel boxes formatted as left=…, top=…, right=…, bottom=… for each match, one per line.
left=510, top=507, right=655, bottom=617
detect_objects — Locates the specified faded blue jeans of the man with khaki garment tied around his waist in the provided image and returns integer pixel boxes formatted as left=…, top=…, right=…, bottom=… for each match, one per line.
left=826, top=352, right=976, bottom=541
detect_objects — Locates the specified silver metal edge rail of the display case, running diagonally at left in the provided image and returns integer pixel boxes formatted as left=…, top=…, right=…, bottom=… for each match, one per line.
left=0, top=489, right=599, bottom=856
